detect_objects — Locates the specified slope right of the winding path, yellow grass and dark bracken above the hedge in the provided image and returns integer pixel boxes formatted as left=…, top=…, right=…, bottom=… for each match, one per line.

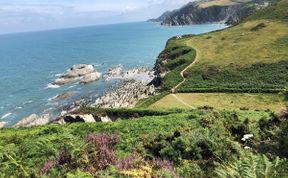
left=180, top=20, right=288, bottom=92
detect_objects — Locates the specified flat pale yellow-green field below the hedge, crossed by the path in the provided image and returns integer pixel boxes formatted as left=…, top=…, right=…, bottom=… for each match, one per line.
left=150, top=93, right=285, bottom=111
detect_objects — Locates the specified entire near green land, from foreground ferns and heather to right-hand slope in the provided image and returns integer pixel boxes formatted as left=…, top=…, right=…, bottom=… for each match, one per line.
left=0, top=0, right=288, bottom=178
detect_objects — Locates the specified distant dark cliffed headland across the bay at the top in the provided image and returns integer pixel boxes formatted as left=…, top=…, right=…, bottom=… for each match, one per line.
left=149, top=0, right=272, bottom=26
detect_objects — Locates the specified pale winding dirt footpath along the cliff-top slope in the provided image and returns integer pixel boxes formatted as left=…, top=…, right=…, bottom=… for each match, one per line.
left=171, top=49, right=199, bottom=109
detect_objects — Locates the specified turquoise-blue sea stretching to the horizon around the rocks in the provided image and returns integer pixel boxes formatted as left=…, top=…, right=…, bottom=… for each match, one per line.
left=0, top=22, right=225, bottom=126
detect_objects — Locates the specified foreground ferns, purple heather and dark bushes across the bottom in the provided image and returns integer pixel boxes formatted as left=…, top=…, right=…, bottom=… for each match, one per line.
left=0, top=109, right=288, bottom=177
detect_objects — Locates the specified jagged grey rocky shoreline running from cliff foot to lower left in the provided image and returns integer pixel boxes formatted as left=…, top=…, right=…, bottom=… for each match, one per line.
left=8, top=65, right=156, bottom=128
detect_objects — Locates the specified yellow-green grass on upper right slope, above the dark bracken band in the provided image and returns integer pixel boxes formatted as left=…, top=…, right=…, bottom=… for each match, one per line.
left=181, top=20, right=288, bottom=68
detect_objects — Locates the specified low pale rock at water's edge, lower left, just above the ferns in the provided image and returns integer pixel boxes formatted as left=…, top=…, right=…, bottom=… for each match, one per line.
left=14, top=114, right=51, bottom=128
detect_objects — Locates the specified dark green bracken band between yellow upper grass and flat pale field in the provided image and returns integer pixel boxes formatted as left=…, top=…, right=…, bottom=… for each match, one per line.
left=178, top=60, right=288, bottom=93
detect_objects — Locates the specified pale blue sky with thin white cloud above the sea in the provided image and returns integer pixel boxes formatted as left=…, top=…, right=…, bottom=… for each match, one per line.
left=0, top=0, right=191, bottom=34
